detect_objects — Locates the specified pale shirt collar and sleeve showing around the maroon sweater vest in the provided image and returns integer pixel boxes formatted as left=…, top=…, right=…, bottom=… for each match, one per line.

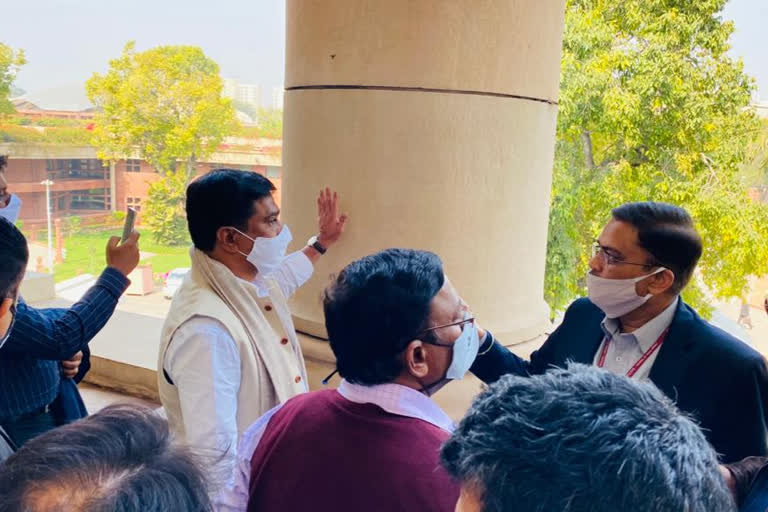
left=214, top=380, right=454, bottom=512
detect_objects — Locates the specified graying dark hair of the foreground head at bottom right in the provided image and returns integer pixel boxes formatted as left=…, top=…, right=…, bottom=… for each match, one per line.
left=441, top=364, right=735, bottom=512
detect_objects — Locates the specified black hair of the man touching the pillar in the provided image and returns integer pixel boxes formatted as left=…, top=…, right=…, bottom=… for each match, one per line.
left=187, top=169, right=275, bottom=252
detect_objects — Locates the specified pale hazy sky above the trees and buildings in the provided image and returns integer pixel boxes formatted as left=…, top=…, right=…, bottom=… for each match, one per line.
left=0, top=0, right=768, bottom=108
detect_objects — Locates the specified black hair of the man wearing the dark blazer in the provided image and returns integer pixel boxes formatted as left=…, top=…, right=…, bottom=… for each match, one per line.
left=611, top=201, right=702, bottom=293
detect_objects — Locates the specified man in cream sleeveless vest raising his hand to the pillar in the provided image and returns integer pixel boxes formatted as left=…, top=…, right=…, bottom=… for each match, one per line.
left=158, top=169, right=346, bottom=491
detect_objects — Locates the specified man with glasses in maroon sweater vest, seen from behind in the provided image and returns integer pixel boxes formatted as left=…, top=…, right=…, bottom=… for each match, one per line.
left=217, top=249, right=468, bottom=512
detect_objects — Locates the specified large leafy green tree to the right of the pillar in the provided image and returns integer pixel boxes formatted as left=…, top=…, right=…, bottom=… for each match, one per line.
left=545, top=0, right=768, bottom=313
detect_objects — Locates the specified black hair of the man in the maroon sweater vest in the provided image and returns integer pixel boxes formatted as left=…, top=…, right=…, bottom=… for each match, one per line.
left=323, top=249, right=445, bottom=386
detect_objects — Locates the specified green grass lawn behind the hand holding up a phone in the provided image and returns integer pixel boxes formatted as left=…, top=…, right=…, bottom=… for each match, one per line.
left=54, top=230, right=189, bottom=283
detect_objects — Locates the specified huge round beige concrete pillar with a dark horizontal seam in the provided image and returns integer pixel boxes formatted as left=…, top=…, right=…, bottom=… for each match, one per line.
left=282, top=0, right=565, bottom=343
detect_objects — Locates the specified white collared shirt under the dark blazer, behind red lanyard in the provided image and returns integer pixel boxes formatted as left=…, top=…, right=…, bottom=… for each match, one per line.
left=593, top=297, right=680, bottom=380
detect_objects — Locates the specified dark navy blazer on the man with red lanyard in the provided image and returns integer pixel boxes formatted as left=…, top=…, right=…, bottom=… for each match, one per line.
left=471, top=298, right=768, bottom=462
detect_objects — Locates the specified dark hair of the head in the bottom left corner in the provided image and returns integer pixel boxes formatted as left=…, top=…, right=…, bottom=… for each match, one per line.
left=0, top=405, right=212, bottom=512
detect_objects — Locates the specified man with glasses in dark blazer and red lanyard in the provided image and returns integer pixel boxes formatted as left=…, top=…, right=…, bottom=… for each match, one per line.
left=472, top=202, right=768, bottom=462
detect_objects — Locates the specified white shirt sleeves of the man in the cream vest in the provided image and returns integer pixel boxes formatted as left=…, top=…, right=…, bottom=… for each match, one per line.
left=163, top=251, right=314, bottom=492
